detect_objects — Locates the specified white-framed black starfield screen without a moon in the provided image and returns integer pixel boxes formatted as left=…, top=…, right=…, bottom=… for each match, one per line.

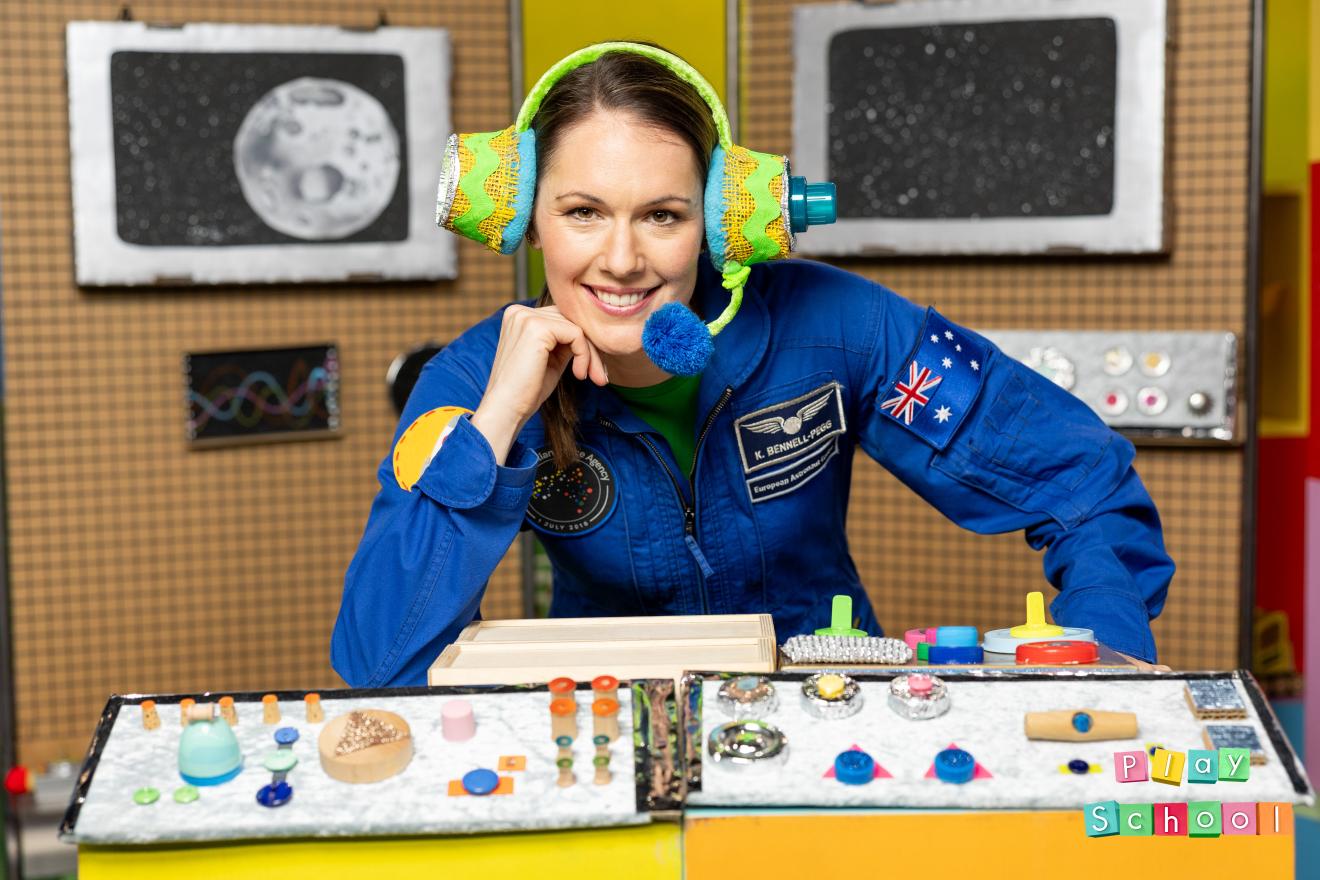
left=792, top=0, right=1167, bottom=256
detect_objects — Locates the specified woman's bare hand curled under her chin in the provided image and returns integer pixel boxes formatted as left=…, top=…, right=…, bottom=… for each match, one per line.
left=471, top=306, right=610, bottom=464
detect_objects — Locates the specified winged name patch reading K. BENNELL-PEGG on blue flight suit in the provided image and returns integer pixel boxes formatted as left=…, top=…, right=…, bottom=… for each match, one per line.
left=734, top=381, right=847, bottom=474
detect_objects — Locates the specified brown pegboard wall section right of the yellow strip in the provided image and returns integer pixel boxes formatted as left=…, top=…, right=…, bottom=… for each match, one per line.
left=738, top=0, right=1253, bottom=669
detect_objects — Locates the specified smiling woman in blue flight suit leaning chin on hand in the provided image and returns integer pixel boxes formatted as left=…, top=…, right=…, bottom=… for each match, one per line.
left=331, top=42, right=1173, bottom=686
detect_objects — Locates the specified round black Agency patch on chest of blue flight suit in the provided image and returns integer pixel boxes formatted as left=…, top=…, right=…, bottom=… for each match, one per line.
left=527, top=447, right=616, bottom=534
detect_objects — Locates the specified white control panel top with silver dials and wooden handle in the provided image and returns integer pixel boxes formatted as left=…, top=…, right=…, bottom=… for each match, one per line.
left=685, top=669, right=1312, bottom=809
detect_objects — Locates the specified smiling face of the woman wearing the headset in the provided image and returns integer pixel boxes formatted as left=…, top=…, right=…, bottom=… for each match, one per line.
left=528, top=111, right=704, bottom=367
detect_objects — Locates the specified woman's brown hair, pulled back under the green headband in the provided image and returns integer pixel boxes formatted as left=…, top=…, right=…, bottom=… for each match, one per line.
left=532, top=44, right=717, bottom=470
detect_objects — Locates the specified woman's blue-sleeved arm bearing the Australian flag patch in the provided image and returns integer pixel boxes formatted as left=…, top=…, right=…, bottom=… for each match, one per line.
left=854, top=278, right=1173, bottom=662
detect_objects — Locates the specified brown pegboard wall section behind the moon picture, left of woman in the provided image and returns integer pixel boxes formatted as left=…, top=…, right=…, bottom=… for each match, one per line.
left=0, top=0, right=521, bottom=764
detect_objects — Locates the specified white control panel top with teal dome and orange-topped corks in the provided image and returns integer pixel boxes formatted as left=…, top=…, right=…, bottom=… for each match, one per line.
left=61, top=674, right=648, bottom=843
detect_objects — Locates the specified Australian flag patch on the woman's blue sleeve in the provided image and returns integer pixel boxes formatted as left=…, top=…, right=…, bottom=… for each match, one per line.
left=879, top=309, right=990, bottom=450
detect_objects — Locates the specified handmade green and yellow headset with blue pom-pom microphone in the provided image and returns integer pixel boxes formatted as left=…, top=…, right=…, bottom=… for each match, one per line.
left=436, top=42, right=834, bottom=376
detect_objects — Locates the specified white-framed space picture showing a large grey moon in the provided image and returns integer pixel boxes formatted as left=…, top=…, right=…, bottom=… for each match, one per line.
left=67, top=21, right=457, bottom=286
